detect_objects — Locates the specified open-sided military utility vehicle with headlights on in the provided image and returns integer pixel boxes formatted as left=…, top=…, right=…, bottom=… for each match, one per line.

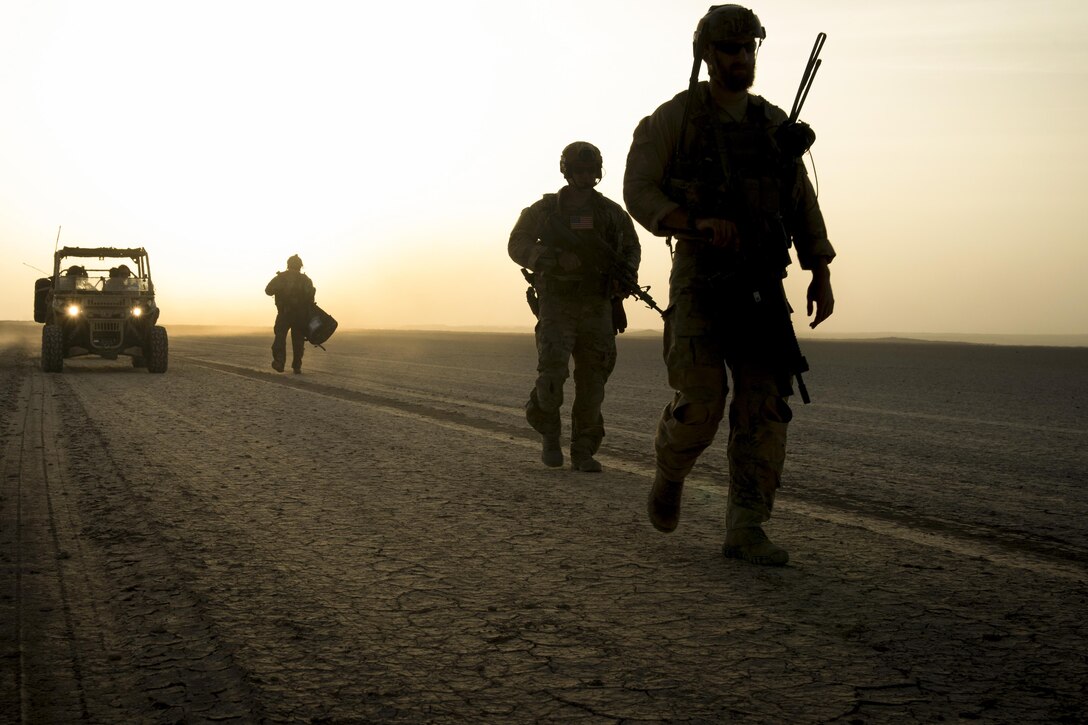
left=34, top=247, right=169, bottom=372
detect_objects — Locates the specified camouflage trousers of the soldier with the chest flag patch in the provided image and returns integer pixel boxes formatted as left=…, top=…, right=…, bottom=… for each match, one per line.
left=526, top=294, right=616, bottom=459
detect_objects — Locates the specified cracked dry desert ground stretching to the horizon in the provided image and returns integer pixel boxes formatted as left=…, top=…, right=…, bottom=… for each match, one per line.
left=0, top=325, right=1088, bottom=723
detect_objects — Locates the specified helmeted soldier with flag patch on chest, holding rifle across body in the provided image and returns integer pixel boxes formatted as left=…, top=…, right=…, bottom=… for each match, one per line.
left=508, top=142, right=641, bottom=472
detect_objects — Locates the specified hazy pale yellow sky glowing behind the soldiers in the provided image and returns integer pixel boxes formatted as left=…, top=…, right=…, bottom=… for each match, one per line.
left=0, top=0, right=1088, bottom=334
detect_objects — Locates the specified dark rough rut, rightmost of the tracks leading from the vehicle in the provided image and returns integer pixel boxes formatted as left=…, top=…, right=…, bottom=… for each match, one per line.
left=53, top=378, right=269, bottom=722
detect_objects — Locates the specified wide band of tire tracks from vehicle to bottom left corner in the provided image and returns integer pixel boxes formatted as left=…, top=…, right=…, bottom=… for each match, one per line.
left=0, top=346, right=266, bottom=723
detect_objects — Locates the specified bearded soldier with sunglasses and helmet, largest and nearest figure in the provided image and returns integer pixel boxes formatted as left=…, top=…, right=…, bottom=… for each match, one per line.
left=623, top=4, right=834, bottom=565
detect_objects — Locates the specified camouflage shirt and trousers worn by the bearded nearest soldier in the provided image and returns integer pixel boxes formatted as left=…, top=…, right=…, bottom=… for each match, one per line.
left=623, top=82, right=834, bottom=529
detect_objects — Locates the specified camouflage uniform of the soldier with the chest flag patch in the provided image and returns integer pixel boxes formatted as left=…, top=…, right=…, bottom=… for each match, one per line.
left=508, top=187, right=641, bottom=462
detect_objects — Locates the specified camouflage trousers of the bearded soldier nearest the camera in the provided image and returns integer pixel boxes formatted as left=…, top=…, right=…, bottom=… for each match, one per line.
left=654, top=289, right=793, bottom=529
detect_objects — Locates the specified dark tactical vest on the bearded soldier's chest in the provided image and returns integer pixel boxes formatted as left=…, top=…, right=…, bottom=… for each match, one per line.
left=666, top=86, right=795, bottom=268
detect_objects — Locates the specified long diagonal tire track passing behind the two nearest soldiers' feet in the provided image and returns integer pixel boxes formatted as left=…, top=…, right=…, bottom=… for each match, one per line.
left=182, top=358, right=1088, bottom=581
